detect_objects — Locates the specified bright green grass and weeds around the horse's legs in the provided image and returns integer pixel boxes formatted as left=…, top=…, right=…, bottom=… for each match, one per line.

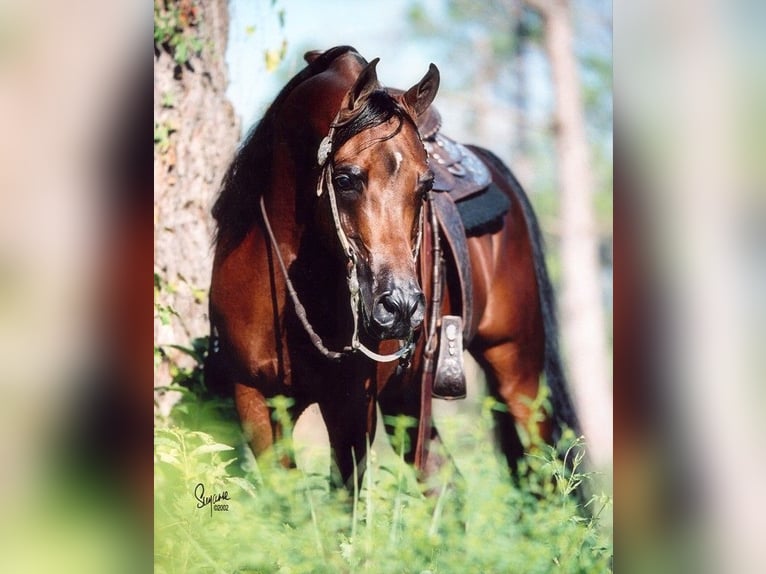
left=154, top=358, right=612, bottom=574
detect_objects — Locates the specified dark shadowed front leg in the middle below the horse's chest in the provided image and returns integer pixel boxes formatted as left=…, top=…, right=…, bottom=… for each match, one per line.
left=318, top=381, right=377, bottom=490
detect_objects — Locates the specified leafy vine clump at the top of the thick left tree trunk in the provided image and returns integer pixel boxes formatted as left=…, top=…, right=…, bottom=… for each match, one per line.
left=154, top=0, right=203, bottom=65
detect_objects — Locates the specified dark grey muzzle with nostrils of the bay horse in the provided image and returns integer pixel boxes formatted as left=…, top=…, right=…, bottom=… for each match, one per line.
left=370, top=281, right=426, bottom=340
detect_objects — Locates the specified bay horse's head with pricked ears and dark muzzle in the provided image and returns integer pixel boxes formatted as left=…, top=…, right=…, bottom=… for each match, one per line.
left=317, top=59, right=439, bottom=346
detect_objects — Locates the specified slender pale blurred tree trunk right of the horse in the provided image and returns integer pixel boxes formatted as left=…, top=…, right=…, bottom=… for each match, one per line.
left=527, top=0, right=612, bottom=466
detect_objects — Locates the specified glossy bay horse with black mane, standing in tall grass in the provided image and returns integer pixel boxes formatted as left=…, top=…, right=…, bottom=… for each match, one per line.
left=205, top=46, right=577, bottom=487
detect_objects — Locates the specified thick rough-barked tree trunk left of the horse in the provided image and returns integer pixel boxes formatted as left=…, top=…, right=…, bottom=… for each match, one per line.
left=154, top=0, right=240, bottom=384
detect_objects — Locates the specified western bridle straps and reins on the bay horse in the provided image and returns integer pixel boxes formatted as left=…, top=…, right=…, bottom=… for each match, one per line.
left=260, top=99, right=430, bottom=363
